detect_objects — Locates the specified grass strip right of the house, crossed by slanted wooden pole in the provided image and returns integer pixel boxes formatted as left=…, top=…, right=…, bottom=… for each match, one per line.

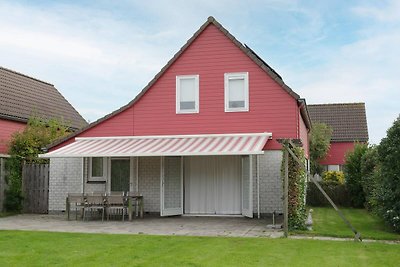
left=295, top=208, right=400, bottom=240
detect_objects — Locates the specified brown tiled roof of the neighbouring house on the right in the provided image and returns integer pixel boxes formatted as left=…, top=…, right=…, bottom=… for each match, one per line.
left=307, top=103, right=368, bottom=142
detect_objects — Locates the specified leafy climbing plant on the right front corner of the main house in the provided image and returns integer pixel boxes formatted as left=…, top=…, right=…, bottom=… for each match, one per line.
left=282, top=147, right=307, bottom=230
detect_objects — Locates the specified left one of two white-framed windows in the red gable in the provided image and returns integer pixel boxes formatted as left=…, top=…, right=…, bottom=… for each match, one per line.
left=176, top=75, right=199, bottom=113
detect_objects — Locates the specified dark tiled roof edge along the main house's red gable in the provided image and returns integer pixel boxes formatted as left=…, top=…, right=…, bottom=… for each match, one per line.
left=48, top=16, right=308, bottom=151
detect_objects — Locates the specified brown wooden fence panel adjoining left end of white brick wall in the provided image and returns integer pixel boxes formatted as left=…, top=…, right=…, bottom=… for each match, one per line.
left=22, top=164, right=49, bottom=213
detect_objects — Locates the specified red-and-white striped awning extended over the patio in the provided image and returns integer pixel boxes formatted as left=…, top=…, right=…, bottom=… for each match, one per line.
left=40, top=133, right=272, bottom=158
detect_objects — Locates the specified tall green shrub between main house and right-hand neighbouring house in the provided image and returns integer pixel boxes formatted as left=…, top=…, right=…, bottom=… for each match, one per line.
left=310, top=123, right=332, bottom=175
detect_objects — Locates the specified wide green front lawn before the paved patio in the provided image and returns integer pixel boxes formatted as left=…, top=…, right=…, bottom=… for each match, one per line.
left=0, top=231, right=400, bottom=266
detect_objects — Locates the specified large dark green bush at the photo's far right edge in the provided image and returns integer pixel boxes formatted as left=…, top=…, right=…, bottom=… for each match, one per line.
left=376, top=116, right=400, bottom=233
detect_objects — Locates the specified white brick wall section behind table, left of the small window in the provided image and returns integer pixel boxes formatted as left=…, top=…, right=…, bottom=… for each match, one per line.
left=49, top=158, right=82, bottom=211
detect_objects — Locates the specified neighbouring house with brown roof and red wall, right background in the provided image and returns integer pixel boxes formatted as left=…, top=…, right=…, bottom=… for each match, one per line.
left=307, top=103, right=368, bottom=171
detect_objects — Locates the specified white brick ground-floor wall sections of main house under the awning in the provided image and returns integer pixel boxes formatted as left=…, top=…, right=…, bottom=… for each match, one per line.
left=49, top=151, right=282, bottom=216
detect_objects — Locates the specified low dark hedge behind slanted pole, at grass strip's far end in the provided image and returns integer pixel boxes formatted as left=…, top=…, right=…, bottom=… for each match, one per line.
left=306, top=182, right=351, bottom=207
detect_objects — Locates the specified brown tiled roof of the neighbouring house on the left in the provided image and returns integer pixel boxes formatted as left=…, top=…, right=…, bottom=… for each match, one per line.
left=0, top=67, right=87, bottom=129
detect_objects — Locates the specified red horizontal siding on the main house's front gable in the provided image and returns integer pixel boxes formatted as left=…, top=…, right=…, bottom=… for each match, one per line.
left=52, top=24, right=299, bottom=150
